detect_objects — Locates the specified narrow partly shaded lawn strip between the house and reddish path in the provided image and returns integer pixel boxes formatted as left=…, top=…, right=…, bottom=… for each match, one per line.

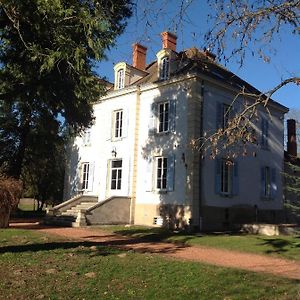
left=96, top=226, right=300, bottom=261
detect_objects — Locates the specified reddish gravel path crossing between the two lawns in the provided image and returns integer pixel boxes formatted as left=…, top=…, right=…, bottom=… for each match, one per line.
left=10, top=223, right=300, bottom=280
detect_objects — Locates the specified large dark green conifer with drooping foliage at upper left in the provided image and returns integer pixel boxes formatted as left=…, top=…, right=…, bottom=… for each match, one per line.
left=0, top=0, right=131, bottom=178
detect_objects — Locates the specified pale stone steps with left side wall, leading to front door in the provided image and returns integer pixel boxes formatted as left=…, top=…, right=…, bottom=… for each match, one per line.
left=44, top=195, right=98, bottom=227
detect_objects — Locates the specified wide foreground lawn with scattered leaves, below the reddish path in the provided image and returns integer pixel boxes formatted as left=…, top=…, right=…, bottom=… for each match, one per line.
left=0, top=229, right=300, bottom=299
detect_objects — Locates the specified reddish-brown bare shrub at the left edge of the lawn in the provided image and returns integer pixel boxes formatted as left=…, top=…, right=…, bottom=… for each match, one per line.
left=0, top=174, right=22, bottom=228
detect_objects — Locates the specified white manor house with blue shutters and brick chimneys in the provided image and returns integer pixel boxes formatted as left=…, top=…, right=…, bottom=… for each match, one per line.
left=48, top=32, right=288, bottom=230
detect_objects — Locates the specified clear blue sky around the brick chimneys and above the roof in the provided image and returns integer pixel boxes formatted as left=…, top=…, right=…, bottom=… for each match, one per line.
left=96, top=0, right=300, bottom=109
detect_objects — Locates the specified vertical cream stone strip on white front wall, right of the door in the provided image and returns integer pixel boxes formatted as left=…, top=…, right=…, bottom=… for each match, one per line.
left=129, top=86, right=141, bottom=224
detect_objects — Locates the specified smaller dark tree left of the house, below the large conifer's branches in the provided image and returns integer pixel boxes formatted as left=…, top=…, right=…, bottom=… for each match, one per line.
left=21, top=114, right=68, bottom=210
